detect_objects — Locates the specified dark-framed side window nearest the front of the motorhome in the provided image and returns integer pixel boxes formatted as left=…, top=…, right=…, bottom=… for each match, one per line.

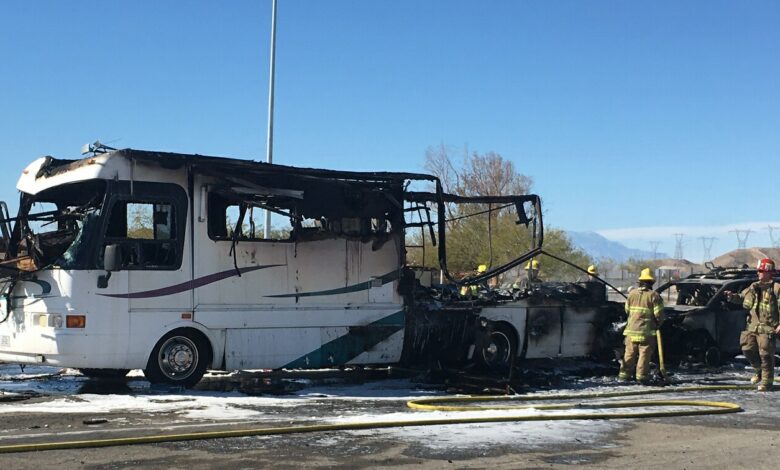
left=104, top=200, right=181, bottom=269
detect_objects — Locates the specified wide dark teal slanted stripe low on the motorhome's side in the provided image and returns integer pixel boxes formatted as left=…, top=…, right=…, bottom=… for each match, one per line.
left=284, top=310, right=406, bottom=369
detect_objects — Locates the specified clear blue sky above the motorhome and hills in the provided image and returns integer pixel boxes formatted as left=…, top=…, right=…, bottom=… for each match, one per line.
left=0, top=0, right=780, bottom=261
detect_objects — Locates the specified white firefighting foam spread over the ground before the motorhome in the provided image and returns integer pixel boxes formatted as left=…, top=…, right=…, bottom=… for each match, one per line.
left=0, top=366, right=780, bottom=450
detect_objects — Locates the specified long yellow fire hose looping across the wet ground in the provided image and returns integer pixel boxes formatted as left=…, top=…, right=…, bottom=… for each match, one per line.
left=0, top=385, right=753, bottom=453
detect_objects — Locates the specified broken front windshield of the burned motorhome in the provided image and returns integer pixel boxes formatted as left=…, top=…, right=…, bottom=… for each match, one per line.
left=0, top=181, right=106, bottom=275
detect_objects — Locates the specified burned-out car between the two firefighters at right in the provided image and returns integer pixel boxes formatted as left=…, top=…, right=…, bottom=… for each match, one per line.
left=657, top=266, right=776, bottom=366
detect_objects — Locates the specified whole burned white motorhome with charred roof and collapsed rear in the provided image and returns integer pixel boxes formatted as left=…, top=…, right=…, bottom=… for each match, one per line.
left=0, top=149, right=617, bottom=386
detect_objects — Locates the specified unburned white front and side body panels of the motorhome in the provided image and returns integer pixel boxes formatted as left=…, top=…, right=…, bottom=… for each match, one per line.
left=0, top=152, right=404, bottom=384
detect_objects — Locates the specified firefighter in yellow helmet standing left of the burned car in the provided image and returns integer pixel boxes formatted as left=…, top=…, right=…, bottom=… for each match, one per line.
left=618, top=268, right=664, bottom=384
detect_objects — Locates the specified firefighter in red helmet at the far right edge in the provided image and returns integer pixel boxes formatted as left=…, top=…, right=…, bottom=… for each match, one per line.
left=730, top=258, right=780, bottom=392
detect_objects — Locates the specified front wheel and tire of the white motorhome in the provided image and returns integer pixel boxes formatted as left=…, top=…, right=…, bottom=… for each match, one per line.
left=144, top=330, right=211, bottom=388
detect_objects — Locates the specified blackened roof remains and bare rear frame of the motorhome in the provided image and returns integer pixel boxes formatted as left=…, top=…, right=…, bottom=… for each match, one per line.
left=0, top=149, right=543, bottom=285
